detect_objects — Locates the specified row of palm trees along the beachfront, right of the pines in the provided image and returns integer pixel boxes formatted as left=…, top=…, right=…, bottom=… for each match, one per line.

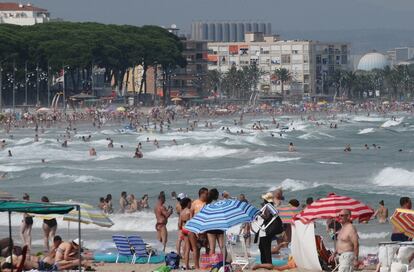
left=206, top=64, right=414, bottom=100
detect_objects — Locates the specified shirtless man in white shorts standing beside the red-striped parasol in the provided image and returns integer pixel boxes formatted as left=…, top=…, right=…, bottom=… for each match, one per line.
left=330, top=210, right=359, bottom=272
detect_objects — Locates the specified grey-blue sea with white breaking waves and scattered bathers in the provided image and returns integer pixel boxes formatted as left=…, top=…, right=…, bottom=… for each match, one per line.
left=0, top=112, right=414, bottom=254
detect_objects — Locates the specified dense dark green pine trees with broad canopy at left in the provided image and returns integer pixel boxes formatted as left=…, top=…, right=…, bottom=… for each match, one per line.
left=0, top=22, right=186, bottom=106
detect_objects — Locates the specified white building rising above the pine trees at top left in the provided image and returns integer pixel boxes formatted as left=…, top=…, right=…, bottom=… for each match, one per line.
left=0, top=3, right=50, bottom=26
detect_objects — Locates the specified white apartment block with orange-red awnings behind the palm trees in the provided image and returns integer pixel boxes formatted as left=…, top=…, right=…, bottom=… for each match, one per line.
left=208, top=33, right=350, bottom=98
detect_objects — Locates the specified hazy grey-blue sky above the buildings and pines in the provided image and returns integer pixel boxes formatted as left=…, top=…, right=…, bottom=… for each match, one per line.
left=11, top=0, right=414, bottom=32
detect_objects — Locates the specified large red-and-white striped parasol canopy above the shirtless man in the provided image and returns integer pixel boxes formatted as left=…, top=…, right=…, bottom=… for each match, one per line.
left=294, top=193, right=374, bottom=223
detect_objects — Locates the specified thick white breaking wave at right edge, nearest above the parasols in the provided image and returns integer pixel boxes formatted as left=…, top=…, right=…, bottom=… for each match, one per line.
left=373, top=167, right=414, bottom=186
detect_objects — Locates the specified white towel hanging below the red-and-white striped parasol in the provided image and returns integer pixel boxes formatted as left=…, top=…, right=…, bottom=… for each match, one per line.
left=291, top=221, right=322, bottom=271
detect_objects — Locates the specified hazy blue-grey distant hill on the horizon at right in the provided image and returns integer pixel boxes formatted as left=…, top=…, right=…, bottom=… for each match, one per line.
left=274, top=29, right=414, bottom=55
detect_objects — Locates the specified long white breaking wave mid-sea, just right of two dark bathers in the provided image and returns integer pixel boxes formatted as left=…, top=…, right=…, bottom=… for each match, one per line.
left=144, top=143, right=246, bottom=159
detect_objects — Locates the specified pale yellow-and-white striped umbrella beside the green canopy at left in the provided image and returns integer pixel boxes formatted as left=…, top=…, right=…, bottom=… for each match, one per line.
left=59, top=201, right=114, bottom=228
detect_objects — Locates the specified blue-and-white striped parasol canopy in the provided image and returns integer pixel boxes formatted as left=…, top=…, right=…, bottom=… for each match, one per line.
left=185, top=199, right=259, bottom=233
